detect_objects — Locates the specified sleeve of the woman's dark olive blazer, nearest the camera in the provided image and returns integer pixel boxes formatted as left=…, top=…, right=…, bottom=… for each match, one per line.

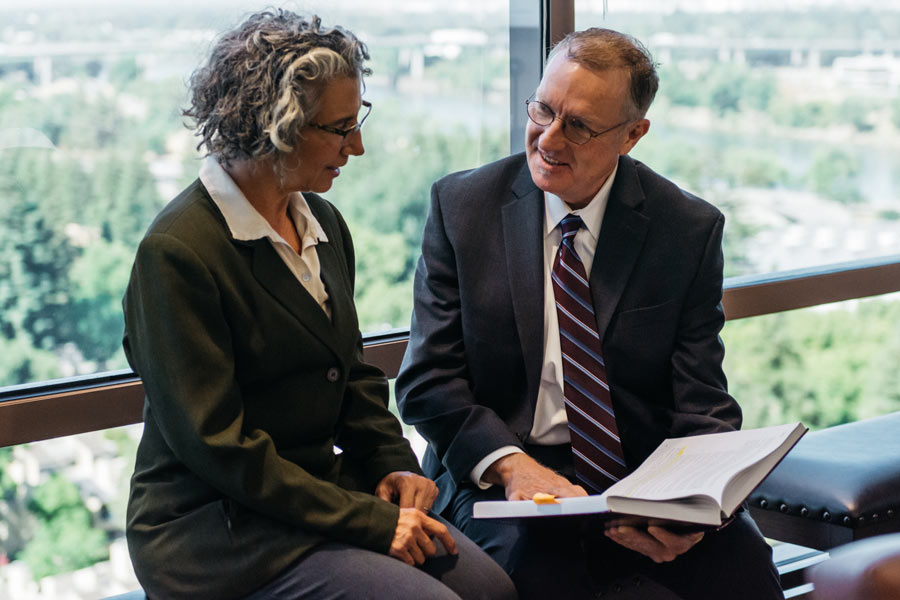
left=125, top=233, right=405, bottom=552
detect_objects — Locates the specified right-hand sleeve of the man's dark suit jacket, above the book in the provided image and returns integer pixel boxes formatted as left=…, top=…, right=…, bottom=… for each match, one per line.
left=669, top=214, right=741, bottom=437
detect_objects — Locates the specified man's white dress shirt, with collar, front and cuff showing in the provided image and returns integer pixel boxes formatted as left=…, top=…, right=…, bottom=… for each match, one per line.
left=471, top=164, right=619, bottom=489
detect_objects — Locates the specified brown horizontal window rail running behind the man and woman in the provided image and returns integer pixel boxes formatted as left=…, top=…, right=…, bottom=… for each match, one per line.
left=0, top=255, right=900, bottom=447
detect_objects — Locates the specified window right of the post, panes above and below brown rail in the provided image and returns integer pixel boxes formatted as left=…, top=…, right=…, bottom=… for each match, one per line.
left=575, top=0, right=900, bottom=428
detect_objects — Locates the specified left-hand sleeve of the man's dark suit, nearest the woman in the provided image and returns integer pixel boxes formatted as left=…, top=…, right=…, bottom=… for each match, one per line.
left=396, top=182, right=522, bottom=482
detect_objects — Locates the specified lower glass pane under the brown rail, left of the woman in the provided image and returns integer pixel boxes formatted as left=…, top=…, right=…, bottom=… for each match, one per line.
left=0, top=425, right=142, bottom=600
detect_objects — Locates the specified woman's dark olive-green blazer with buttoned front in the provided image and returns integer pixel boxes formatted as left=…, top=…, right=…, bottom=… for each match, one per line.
left=124, top=181, right=421, bottom=599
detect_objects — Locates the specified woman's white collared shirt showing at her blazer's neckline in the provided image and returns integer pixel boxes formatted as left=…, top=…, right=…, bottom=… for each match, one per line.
left=200, top=156, right=331, bottom=319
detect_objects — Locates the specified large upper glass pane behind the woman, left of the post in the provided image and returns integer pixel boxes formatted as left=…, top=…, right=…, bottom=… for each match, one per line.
left=0, top=0, right=509, bottom=386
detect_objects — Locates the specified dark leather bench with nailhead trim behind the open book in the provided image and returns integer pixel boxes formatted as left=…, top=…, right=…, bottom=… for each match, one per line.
left=748, top=412, right=900, bottom=550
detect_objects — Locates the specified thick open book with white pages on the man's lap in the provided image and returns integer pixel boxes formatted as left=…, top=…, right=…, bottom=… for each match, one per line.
left=473, top=423, right=807, bottom=527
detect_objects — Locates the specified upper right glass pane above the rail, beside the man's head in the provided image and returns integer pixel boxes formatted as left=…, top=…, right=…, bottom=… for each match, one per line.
left=575, top=0, right=900, bottom=276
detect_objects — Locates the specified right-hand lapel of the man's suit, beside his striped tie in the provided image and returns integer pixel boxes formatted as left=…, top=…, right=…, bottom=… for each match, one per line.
left=590, top=156, right=649, bottom=342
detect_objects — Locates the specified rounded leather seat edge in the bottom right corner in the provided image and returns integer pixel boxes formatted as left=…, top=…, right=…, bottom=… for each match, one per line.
left=808, top=533, right=900, bottom=600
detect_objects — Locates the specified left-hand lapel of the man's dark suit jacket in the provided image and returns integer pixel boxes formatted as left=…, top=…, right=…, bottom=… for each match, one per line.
left=501, top=165, right=544, bottom=408
